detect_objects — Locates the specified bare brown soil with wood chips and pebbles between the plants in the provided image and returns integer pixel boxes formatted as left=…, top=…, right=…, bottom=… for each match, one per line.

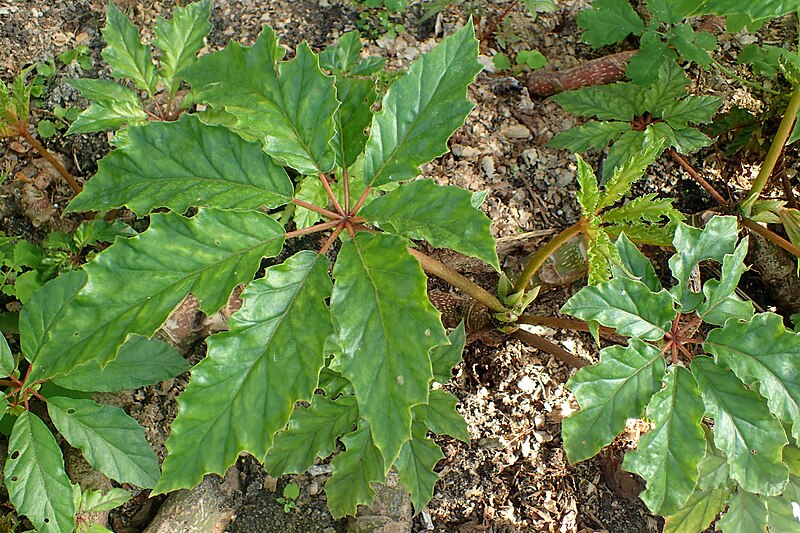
left=0, top=0, right=794, bottom=533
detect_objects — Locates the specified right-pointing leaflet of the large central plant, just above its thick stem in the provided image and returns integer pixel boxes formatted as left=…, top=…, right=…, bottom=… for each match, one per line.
left=360, top=179, right=500, bottom=271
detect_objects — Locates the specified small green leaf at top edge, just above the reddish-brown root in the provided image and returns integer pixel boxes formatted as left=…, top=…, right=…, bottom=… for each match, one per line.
left=576, top=0, right=644, bottom=48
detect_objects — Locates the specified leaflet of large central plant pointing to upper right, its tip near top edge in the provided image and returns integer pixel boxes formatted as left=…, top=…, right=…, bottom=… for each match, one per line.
left=364, top=21, right=482, bottom=188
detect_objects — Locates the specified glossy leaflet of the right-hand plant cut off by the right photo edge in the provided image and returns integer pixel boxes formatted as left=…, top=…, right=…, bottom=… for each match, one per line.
left=703, top=313, right=800, bottom=440
